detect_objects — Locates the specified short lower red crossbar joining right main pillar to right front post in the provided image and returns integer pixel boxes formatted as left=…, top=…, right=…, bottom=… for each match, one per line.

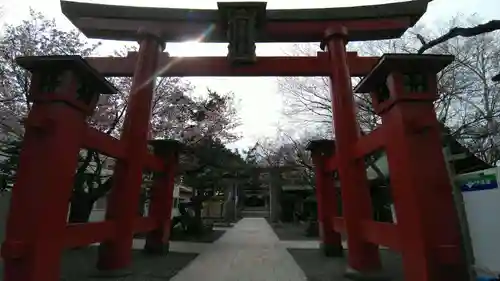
left=361, top=221, right=401, bottom=251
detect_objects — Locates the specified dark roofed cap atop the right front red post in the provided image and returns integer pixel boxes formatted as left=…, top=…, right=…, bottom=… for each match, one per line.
left=355, top=54, right=454, bottom=114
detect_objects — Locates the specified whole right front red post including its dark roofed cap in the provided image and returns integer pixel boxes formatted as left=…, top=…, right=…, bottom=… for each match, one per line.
left=355, top=54, right=469, bottom=280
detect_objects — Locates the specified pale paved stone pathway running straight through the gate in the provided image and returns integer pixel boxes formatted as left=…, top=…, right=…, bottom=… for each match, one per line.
left=171, top=218, right=307, bottom=281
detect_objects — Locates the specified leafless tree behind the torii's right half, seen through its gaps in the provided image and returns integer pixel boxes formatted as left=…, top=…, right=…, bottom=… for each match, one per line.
left=278, top=16, right=500, bottom=164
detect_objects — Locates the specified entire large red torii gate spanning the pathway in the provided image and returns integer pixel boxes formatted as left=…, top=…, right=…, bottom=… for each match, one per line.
left=2, top=1, right=466, bottom=281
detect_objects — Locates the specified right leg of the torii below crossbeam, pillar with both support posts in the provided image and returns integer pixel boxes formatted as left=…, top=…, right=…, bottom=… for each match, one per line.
left=308, top=51, right=468, bottom=280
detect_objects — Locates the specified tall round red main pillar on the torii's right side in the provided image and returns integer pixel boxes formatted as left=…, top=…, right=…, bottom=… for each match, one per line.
left=327, top=29, right=381, bottom=272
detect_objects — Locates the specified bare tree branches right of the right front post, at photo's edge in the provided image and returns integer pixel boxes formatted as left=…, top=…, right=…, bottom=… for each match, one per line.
left=418, top=17, right=500, bottom=162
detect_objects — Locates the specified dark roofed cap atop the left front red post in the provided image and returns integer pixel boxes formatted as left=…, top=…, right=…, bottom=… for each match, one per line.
left=16, top=56, right=118, bottom=115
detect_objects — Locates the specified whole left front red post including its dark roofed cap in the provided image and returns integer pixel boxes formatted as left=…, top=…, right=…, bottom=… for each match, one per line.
left=1, top=56, right=116, bottom=281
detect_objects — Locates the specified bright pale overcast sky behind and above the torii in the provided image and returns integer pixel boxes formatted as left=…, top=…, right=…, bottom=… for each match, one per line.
left=0, top=0, right=500, bottom=148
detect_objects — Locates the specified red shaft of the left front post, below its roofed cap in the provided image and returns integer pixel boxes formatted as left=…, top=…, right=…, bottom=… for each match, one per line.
left=2, top=87, right=86, bottom=281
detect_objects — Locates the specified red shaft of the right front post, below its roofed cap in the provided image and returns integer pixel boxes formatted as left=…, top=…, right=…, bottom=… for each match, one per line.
left=382, top=73, right=468, bottom=281
